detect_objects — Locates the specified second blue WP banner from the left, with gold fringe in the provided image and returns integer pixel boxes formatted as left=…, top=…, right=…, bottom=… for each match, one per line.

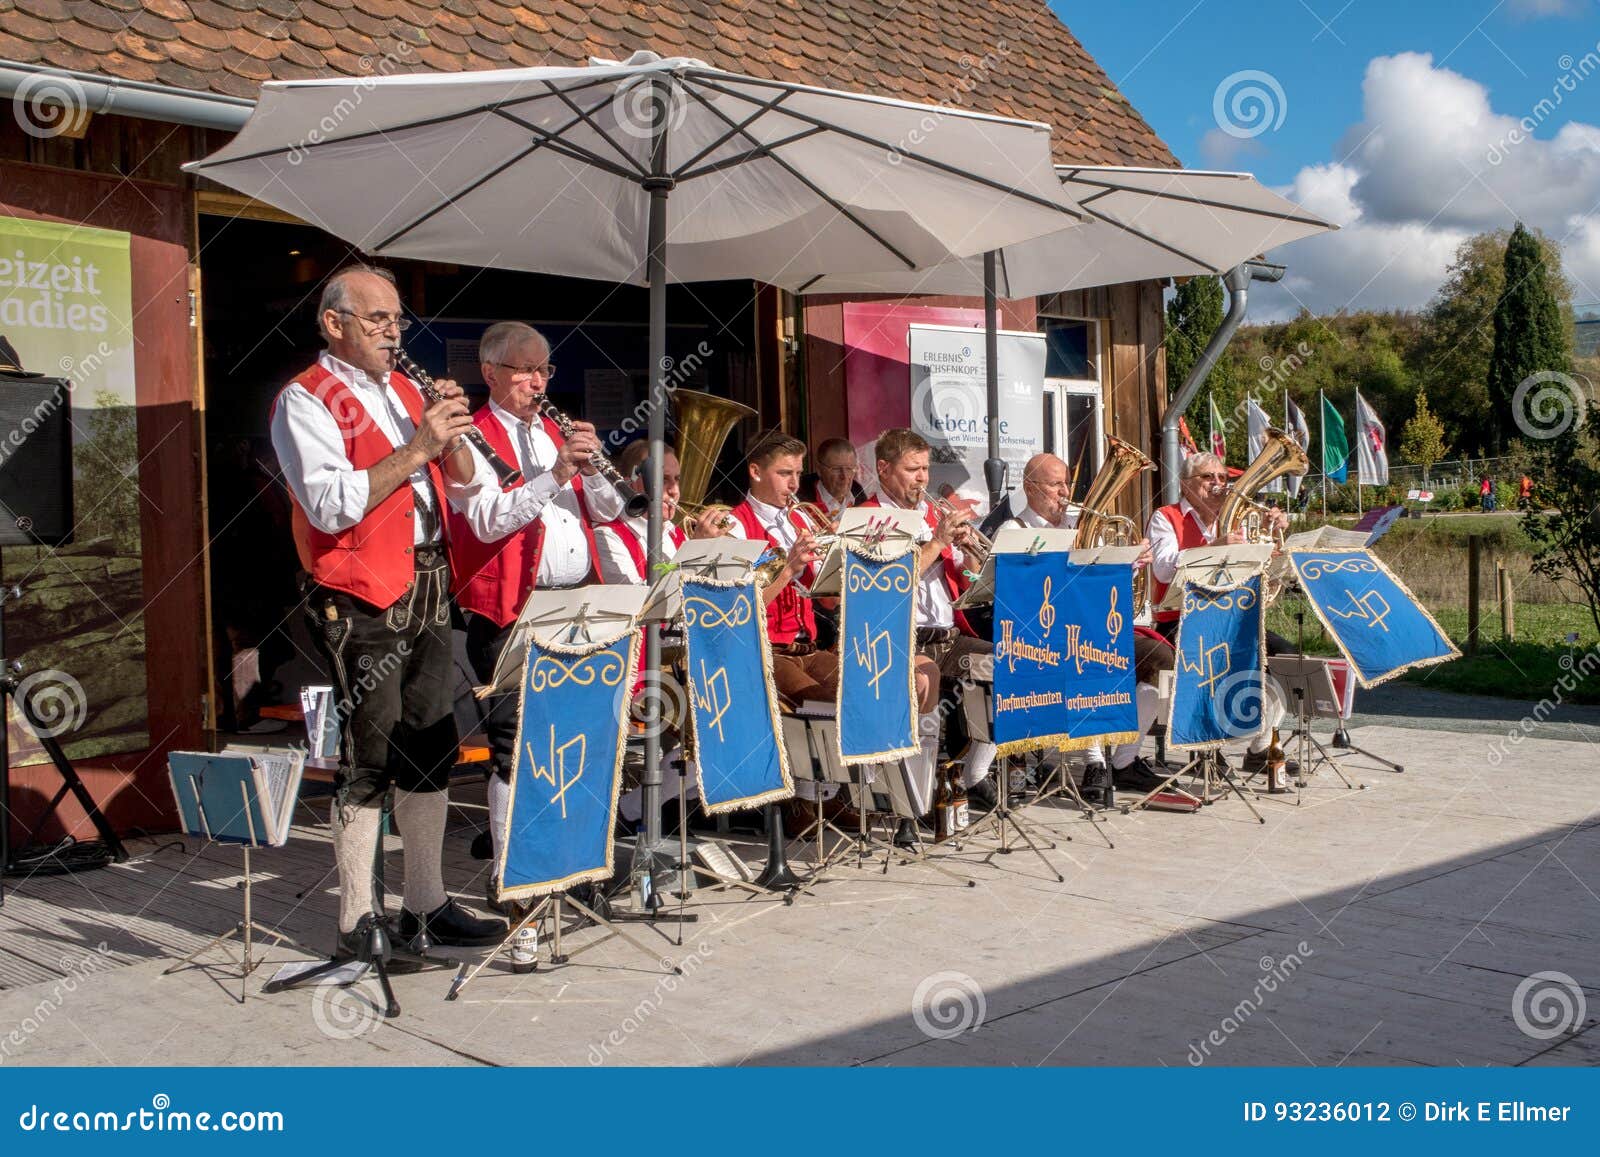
left=683, top=579, right=794, bottom=815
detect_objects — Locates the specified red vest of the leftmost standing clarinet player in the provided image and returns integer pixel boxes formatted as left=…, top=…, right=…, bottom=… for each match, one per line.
left=272, top=365, right=448, bottom=610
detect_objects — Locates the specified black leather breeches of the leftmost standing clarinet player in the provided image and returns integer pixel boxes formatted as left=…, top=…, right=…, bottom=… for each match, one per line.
left=304, top=547, right=459, bottom=807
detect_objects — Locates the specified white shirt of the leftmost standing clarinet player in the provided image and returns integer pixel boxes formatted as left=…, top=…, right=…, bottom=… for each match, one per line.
left=272, top=350, right=442, bottom=546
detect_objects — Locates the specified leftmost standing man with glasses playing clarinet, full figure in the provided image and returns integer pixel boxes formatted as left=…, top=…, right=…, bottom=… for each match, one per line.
left=272, top=266, right=504, bottom=957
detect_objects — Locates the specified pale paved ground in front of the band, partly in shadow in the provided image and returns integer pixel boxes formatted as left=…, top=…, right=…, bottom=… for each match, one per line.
left=0, top=688, right=1600, bottom=1066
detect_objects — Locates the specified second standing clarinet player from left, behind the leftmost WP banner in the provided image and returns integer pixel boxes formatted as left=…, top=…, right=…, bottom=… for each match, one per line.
left=446, top=322, right=624, bottom=906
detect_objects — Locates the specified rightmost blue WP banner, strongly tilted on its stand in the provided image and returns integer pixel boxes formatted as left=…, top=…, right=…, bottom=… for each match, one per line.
left=1290, top=550, right=1461, bottom=688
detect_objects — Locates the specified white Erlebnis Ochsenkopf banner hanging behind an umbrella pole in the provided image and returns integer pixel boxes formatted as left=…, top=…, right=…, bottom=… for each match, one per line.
left=909, top=325, right=1045, bottom=517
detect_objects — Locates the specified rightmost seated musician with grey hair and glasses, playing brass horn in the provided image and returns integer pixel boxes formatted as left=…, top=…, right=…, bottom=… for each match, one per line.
left=1146, top=453, right=1299, bottom=775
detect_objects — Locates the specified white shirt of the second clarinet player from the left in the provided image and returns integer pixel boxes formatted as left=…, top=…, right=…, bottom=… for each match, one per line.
left=445, top=398, right=622, bottom=589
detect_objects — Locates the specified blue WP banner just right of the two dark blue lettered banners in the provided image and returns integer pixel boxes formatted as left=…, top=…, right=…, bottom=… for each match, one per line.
left=1166, top=574, right=1267, bottom=747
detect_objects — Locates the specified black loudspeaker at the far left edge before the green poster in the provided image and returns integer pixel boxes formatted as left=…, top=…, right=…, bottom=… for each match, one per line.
left=0, top=373, right=72, bottom=546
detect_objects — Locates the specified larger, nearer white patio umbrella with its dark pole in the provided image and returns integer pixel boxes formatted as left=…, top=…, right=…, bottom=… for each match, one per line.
left=186, top=53, right=1078, bottom=896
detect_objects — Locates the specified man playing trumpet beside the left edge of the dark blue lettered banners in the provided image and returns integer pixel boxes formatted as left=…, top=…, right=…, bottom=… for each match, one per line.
left=862, top=429, right=998, bottom=842
